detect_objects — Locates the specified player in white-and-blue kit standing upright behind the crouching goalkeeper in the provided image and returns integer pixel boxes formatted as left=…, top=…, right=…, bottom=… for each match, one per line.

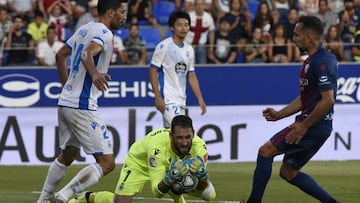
left=149, top=10, right=206, bottom=128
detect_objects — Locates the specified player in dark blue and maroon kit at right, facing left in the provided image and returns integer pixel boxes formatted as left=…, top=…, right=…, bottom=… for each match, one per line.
left=240, top=16, right=338, bottom=203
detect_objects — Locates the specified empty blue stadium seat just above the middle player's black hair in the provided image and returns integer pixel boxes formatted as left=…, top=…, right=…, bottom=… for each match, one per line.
left=153, top=1, right=175, bottom=25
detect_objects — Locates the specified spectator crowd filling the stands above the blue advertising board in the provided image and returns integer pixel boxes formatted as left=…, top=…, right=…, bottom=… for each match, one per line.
left=0, top=0, right=360, bottom=66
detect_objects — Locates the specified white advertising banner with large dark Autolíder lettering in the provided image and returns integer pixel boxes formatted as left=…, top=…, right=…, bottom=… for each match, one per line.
left=0, top=104, right=360, bottom=165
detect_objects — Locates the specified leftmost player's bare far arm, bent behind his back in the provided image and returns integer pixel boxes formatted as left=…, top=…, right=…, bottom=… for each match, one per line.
left=55, top=45, right=71, bottom=86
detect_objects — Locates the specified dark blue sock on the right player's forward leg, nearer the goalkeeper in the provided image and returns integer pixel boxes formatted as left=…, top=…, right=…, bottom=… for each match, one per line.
left=247, top=155, right=273, bottom=203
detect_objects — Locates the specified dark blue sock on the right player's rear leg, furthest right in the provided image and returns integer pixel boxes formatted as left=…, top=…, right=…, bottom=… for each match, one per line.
left=289, top=172, right=336, bottom=203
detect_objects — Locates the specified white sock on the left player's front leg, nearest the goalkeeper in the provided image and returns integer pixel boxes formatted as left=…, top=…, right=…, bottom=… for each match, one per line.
left=56, top=163, right=103, bottom=201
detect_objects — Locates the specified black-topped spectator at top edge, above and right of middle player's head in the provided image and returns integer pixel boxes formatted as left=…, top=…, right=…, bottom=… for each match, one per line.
left=225, top=0, right=251, bottom=51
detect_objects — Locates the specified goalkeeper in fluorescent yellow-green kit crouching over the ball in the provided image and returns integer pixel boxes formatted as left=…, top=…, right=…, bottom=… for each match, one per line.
left=69, top=115, right=216, bottom=203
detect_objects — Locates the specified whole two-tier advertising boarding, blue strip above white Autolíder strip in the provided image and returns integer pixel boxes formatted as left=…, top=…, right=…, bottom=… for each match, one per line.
left=0, top=64, right=360, bottom=165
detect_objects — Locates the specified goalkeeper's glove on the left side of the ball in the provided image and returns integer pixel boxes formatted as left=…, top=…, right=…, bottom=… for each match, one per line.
left=163, top=158, right=189, bottom=186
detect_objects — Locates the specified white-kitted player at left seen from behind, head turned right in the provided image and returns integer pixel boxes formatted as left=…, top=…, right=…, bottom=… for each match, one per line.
left=38, top=0, right=126, bottom=203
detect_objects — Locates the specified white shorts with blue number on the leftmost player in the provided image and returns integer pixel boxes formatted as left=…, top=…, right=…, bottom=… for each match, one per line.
left=58, top=107, right=113, bottom=156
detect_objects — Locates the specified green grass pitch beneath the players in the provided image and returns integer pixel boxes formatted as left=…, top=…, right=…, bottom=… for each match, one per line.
left=0, top=161, right=360, bottom=203
